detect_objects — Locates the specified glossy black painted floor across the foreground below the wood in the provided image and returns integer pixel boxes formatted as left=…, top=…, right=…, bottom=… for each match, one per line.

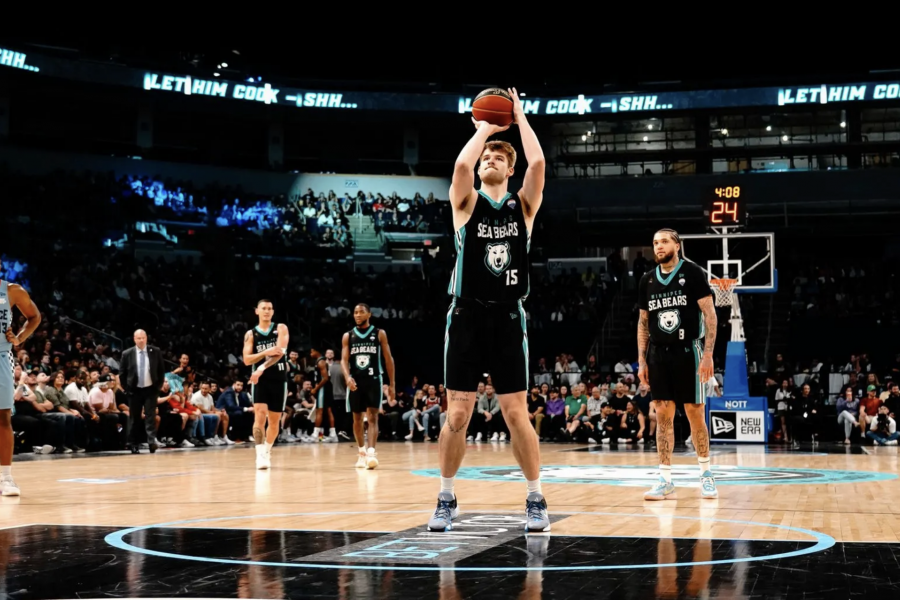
left=0, top=525, right=900, bottom=600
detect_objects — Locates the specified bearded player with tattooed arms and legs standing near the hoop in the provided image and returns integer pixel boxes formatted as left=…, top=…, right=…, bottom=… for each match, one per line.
left=638, top=229, right=719, bottom=500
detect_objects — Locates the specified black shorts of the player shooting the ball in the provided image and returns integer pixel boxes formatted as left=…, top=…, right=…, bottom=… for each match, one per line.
left=444, top=298, right=529, bottom=394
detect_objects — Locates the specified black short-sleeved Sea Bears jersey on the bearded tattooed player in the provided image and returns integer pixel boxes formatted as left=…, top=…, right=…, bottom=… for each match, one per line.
left=638, top=260, right=712, bottom=346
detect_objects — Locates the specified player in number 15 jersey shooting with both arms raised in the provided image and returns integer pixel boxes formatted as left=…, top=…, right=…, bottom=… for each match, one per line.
left=428, top=89, right=550, bottom=532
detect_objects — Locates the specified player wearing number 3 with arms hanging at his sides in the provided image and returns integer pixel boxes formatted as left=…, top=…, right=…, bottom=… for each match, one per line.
left=341, top=304, right=397, bottom=469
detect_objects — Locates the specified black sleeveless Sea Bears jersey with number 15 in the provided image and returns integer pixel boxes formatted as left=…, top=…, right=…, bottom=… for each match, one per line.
left=447, top=191, right=531, bottom=302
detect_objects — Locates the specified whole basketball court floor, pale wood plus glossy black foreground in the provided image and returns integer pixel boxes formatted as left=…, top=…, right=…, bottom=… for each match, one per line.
left=0, top=443, right=900, bottom=598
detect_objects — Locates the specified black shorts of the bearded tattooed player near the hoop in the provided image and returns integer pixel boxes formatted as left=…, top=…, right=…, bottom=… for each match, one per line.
left=647, top=340, right=706, bottom=406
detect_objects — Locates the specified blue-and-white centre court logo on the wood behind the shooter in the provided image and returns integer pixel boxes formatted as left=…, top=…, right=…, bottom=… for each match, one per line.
left=412, top=463, right=897, bottom=487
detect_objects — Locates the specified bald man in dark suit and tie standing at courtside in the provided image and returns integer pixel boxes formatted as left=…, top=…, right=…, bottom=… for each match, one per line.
left=119, top=329, right=166, bottom=454
